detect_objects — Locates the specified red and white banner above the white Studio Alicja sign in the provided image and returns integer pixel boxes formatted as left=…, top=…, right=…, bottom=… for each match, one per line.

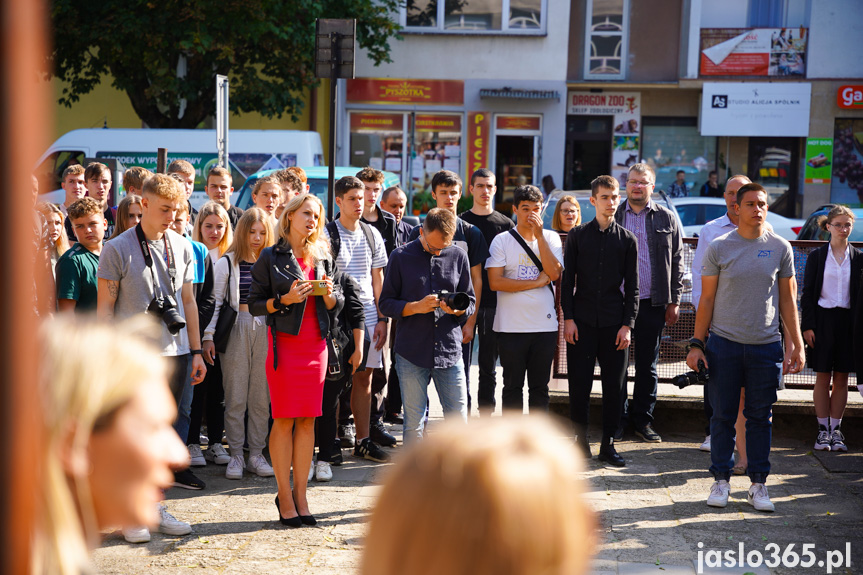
left=701, top=28, right=809, bottom=77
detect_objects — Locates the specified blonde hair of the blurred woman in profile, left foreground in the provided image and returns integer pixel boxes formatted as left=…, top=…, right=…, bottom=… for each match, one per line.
left=30, top=316, right=169, bottom=575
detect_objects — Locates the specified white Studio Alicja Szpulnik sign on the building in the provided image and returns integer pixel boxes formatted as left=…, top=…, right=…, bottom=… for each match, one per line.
left=701, top=82, right=812, bottom=137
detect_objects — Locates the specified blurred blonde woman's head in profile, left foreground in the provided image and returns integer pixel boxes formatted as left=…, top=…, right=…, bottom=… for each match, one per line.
left=31, top=316, right=188, bottom=575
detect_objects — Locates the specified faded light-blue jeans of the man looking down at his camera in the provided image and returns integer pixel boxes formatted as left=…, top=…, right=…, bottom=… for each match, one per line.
left=396, top=354, right=467, bottom=443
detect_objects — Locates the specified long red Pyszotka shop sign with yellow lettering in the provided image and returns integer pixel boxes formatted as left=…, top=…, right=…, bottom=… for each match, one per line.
left=347, top=78, right=464, bottom=105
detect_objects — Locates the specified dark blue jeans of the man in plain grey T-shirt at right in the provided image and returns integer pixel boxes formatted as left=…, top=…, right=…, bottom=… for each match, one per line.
left=707, top=334, right=783, bottom=483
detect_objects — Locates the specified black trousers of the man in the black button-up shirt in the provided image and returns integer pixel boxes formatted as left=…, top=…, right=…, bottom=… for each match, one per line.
left=566, top=325, right=629, bottom=440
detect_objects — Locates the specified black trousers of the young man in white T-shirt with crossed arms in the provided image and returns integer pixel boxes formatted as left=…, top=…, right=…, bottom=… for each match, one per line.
left=497, top=331, right=557, bottom=413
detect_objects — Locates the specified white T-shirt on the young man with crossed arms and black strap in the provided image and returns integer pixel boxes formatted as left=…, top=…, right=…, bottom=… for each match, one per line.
left=485, top=230, right=563, bottom=333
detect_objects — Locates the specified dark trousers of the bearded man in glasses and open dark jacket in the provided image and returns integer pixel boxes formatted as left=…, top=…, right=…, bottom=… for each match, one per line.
left=621, top=298, right=665, bottom=428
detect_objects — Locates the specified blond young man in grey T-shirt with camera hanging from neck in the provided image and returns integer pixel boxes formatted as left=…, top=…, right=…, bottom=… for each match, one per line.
left=96, top=174, right=207, bottom=498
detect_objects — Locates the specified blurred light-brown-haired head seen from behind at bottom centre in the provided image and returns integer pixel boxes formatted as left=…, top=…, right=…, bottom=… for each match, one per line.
left=361, top=415, right=594, bottom=575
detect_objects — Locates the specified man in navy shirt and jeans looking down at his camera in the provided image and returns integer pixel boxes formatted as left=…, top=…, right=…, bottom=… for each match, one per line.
left=380, top=208, right=476, bottom=443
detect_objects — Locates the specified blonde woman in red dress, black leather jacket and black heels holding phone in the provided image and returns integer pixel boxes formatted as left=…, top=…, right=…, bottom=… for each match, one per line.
left=248, top=194, right=344, bottom=527
